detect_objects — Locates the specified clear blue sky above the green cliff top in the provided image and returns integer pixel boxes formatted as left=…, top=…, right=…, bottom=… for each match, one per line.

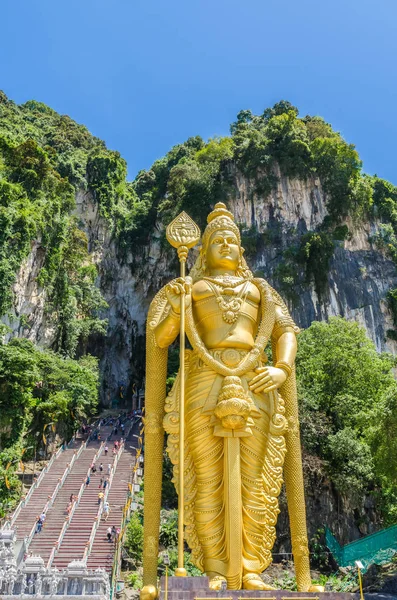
left=0, top=0, right=397, bottom=184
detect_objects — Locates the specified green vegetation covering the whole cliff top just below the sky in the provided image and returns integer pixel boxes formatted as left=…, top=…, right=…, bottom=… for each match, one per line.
left=0, top=94, right=397, bottom=310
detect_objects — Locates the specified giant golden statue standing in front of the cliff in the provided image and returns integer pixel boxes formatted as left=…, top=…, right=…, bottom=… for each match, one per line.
left=142, top=203, right=318, bottom=598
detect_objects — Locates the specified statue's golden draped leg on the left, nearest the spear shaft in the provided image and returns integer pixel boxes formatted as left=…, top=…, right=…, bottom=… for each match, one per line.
left=186, top=368, right=227, bottom=587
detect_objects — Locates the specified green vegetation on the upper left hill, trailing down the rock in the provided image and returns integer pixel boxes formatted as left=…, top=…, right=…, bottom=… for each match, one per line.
left=0, top=96, right=108, bottom=356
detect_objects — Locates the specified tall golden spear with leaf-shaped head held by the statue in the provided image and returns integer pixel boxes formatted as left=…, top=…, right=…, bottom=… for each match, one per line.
left=166, top=212, right=200, bottom=577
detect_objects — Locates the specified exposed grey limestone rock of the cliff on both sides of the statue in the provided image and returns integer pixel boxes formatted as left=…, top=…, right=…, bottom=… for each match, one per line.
left=7, top=168, right=397, bottom=404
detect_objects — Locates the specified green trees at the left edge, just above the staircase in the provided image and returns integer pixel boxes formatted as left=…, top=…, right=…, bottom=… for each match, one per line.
left=0, top=338, right=98, bottom=516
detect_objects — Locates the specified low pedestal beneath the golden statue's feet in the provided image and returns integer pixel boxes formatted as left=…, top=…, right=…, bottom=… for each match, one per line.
left=159, top=576, right=360, bottom=600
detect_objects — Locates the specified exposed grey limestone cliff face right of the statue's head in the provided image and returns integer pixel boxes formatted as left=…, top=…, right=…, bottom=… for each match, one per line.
left=230, top=166, right=397, bottom=353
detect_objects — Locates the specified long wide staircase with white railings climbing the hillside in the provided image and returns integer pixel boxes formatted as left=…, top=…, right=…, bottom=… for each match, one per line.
left=13, top=414, right=138, bottom=574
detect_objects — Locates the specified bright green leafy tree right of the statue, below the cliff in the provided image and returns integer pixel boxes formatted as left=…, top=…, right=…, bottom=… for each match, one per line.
left=297, top=317, right=397, bottom=519
